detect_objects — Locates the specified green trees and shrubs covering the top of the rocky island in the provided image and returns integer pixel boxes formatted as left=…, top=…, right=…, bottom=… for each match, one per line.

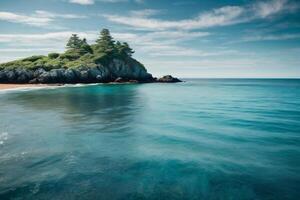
left=0, top=29, right=142, bottom=70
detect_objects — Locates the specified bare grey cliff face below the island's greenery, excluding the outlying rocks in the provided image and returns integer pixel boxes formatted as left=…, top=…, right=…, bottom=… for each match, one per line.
left=0, top=59, right=154, bottom=83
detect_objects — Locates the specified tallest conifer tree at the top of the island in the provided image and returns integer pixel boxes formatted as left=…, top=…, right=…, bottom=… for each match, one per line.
left=96, top=29, right=115, bottom=53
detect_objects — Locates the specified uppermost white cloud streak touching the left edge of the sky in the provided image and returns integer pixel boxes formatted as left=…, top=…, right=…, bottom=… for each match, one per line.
left=0, top=10, right=86, bottom=27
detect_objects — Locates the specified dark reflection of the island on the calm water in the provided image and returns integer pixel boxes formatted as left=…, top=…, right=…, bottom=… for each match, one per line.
left=2, top=85, right=146, bottom=130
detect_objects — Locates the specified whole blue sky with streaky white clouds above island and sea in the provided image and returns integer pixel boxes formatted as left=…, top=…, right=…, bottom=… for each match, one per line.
left=0, top=0, right=300, bottom=78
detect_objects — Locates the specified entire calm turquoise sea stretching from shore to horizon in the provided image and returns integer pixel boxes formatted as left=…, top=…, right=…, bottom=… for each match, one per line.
left=0, top=79, right=300, bottom=200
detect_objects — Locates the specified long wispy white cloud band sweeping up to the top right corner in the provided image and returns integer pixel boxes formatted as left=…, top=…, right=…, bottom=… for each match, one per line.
left=104, top=0, right=299, bottom=30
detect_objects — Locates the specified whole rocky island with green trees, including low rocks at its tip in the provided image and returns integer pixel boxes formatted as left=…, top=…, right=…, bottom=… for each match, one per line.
left=0, top=29, right=180, bottom=84
